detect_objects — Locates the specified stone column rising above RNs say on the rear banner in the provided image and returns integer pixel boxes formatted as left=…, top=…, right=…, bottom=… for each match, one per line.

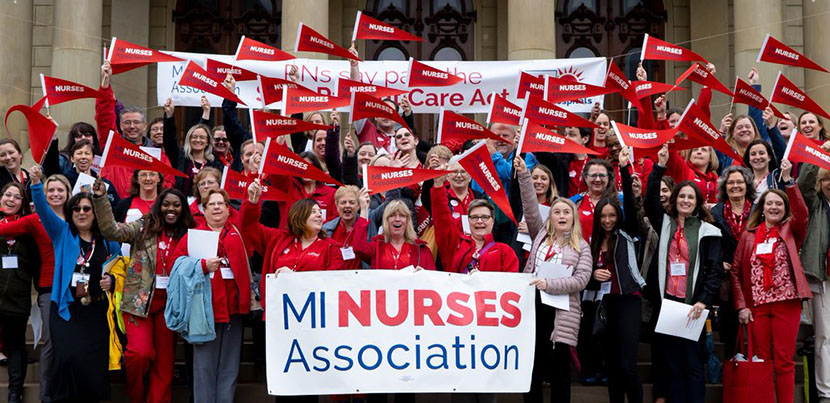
left=282, top=0, right=328, bottom=59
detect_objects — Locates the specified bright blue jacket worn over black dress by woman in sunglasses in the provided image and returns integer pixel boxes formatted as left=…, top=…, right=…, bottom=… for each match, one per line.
left=31, top=183, right=121, bottom=320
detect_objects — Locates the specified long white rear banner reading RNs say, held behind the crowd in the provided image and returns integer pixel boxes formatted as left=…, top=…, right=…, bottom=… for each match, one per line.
left=157, top=52, right=607, bottom=113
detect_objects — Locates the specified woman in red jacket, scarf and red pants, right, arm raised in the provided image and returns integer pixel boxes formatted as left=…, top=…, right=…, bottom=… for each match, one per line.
left=730, top=160, right=812, bottom=402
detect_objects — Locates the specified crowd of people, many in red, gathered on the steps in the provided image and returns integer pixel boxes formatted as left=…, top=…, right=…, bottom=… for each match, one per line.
left=0, top=45, right=830, bottom=403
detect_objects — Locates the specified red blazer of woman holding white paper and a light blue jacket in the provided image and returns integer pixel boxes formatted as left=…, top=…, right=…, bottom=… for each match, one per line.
left=173, top=219, right=251, bottom=323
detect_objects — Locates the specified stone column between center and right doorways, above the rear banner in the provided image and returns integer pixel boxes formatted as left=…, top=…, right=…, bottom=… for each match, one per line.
left=507, top=0, right=556, bottom=60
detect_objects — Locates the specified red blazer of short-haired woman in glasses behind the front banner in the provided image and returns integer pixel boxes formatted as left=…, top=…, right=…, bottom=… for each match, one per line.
left=430, top=186, right=519, bottom=273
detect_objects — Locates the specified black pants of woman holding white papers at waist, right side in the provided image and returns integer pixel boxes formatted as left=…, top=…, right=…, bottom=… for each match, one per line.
left=656, top=334, right=706, bottom=403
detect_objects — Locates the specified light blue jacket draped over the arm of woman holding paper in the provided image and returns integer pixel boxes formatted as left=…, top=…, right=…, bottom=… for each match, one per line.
left=164, top=256, right=216, bottom=343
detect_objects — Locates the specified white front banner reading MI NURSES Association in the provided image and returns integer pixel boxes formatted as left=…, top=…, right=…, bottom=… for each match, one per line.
left=265, top=270, right=536, bottom=395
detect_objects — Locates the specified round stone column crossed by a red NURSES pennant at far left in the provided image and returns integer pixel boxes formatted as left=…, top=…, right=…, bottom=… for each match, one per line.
left=51, top=0, right=103, bottom=132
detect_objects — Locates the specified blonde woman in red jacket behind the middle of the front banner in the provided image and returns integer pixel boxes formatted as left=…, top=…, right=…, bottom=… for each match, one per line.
left=354, top=199, right=438, bottom=270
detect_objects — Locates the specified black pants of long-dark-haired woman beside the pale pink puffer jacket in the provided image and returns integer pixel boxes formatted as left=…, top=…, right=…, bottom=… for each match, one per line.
left=603, top=294, right=643, bottom=403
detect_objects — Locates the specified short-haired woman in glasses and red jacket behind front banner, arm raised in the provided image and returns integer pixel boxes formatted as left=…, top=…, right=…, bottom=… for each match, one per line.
left=432, top=172, right=519, bottom=273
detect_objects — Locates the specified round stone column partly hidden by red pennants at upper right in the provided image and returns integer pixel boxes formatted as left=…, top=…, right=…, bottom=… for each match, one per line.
left=736, top=0, right=784, bottom=102
